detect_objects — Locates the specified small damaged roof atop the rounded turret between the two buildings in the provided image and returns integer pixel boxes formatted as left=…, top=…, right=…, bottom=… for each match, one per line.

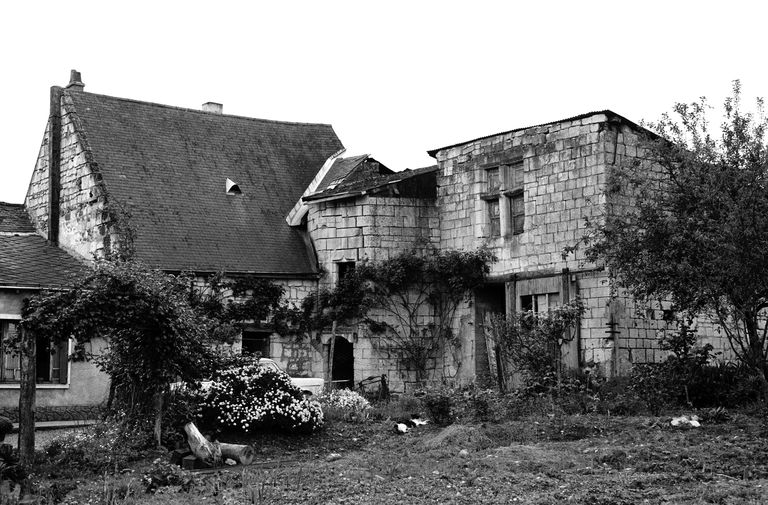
left=302, top=157, right=437, bottom=202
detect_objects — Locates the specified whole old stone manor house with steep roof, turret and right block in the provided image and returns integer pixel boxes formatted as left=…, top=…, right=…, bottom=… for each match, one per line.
left=0, top=71, right=722, bottom=406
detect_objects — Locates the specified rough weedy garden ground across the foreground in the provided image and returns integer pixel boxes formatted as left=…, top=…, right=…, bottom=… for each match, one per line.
left=58, top=414, right=768, bottom=505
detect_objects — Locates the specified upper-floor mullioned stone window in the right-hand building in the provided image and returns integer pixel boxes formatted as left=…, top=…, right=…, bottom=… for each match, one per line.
left=480, top=162, right=525, bottom=237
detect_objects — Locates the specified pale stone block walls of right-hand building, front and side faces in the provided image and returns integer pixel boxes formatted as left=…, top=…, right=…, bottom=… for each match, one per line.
left=435, top=113, right=727, bottom=373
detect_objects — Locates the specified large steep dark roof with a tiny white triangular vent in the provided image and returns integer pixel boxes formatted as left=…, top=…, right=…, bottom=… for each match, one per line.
left=64, top=90, right=342, bottom=276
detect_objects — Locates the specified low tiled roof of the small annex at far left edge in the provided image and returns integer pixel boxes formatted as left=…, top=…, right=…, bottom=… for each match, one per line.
left=0, top=202, right=88, bottom=288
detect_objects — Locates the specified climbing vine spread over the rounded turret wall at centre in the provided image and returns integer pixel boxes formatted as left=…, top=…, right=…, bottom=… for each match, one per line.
left=320, top=249, right=495, bottom=382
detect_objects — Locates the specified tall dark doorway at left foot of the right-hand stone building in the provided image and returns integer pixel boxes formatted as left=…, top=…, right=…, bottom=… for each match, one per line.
left=475, top=282, right=506, bottom=387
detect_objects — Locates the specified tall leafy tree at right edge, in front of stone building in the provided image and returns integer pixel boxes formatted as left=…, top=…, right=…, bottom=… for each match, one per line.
left=588, top=81, right=768, bottom=398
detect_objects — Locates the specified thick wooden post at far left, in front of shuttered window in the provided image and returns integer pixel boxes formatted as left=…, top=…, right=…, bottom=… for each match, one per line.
left=19, top=327, right=37, bottom=466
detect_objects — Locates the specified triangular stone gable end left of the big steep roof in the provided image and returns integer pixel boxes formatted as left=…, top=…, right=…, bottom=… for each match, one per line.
left=25, top=92, right=120, bottom=261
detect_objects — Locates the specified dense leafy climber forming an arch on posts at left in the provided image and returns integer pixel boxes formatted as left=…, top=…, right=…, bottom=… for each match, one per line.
left=22, top=261, right=217, bottom=444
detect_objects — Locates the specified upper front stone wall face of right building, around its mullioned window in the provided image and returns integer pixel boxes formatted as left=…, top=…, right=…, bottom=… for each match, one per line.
left=436, top=114, right=607, bottom=276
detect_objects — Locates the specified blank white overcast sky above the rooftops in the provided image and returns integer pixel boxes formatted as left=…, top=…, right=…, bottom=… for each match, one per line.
left=0, top=0, right=768, bottom=202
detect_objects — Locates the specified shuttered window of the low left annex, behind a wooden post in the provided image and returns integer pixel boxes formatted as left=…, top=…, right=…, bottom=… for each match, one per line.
left=0, top=320, right=69, bottom=384
